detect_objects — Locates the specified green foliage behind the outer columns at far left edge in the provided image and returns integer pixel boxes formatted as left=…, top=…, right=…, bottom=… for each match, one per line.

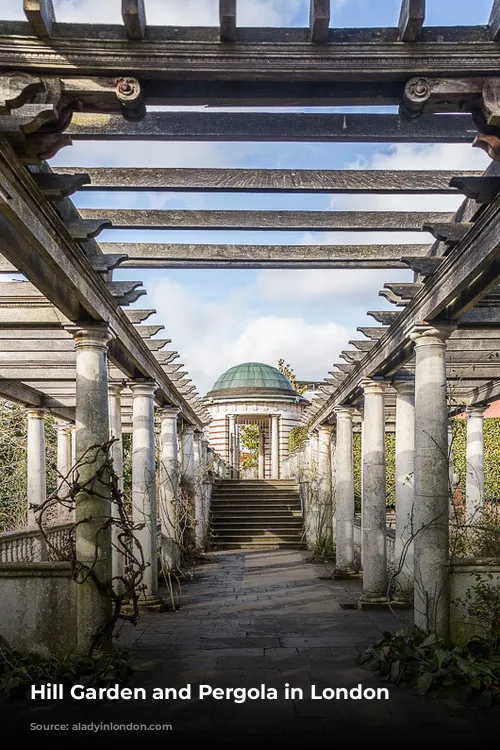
left=0, top=399, right=58, bottom=532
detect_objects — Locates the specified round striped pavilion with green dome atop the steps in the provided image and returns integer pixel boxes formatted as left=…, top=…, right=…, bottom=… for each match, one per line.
left=205, top=362, right=309, bottom=479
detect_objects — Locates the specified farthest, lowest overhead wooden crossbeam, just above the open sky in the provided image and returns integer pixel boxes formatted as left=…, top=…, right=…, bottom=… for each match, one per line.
left=100, top=242, right=429, bottom=268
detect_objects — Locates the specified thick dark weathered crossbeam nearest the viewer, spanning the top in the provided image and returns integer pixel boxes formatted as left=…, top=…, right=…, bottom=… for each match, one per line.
left=0, top=21, right=498, bottom=84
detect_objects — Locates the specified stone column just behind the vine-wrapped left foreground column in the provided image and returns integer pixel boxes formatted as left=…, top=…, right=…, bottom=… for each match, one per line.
left=130, top=380, right=162, bottom=610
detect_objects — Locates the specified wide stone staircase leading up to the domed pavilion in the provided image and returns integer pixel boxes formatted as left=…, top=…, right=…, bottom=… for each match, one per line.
left=211, top=479, right=305, bottom=549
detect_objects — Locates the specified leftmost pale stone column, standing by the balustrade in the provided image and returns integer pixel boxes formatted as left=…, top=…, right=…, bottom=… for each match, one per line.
left=27, top=409, right=47, bottom=529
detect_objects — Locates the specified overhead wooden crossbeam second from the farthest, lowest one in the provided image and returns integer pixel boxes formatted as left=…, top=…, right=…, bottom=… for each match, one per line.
left=85, top=208, right=454, bottom=236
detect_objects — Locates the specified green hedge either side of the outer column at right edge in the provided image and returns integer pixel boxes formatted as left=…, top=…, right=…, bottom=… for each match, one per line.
left=452, top=417, right=500, bottom=500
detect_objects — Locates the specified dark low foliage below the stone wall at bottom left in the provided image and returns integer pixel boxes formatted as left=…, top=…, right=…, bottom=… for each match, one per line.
left=0, top=644, right=132, bottom=700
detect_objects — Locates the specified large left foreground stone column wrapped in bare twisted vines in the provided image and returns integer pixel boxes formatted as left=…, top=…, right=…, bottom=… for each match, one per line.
left=73, top=324, right=112, bottom=651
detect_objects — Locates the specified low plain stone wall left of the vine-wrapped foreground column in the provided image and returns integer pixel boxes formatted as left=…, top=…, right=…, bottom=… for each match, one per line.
left=0, top=562, right=76, bottom=654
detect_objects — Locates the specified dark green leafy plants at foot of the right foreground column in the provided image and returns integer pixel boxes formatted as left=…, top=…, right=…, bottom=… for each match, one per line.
left=359, top=629, right=500, bottom=707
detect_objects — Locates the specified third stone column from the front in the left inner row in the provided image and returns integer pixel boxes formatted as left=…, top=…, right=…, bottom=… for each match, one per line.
left=159, top=407, right=180, bottom=570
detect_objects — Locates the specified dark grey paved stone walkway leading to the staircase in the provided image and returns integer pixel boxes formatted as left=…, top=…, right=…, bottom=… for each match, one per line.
left=3, top=550, right=500, bottom=745
